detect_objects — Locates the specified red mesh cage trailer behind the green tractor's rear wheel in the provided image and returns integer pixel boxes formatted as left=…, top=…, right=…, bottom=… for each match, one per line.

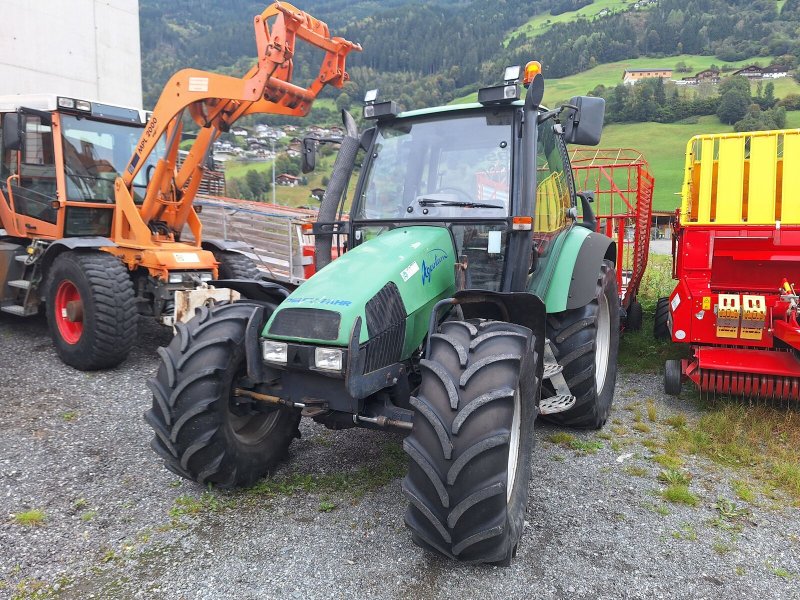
left=570, top=148, right=655, bottom=322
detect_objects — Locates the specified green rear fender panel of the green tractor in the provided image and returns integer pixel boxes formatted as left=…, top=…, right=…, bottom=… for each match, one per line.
left=528, top=226, right=592, bottom=313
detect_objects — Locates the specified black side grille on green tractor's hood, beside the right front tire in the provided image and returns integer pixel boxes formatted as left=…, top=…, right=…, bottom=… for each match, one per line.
left=364, top=281, right=407, bottom=373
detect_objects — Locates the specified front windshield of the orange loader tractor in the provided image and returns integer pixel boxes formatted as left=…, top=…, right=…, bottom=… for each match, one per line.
left=61, top=114, right=163, bottom=203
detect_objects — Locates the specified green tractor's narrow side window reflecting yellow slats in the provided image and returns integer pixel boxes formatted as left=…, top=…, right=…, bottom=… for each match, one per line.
left=533, top=120, right=572, bottom=257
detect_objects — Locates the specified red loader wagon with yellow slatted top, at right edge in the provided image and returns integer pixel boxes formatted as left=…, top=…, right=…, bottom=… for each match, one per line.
left=665, top=129, right=800, bottom=400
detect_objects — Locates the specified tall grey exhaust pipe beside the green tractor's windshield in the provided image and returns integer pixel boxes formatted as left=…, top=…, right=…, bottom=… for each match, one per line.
left=314, top=110, right=361, bottom=271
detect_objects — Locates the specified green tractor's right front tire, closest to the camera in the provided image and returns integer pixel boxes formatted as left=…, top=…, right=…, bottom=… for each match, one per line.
left=402, top=321, right=542, bottom=565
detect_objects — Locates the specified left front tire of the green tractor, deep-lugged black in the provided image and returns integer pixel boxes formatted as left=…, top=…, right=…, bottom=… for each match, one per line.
left=144, top=303, right=300, bottom=488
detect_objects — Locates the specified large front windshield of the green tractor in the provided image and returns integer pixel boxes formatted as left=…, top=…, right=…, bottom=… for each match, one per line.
left=354, top=110, right=513, bottom=221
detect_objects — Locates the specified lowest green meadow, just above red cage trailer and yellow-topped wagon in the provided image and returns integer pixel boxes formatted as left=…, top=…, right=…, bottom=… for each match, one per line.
left=600, top=111, right=800, bottom=210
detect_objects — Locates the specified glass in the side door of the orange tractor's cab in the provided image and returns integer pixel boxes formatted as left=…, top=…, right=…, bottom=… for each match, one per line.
left=9, top=115, right=58, bottom=223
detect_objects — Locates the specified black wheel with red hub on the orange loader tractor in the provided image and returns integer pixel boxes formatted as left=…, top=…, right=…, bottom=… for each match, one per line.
left=45, top=251, right=139, bottom=371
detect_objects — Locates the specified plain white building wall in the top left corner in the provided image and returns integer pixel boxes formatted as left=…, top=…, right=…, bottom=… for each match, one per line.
left=0, top=0, right=142, bottom=108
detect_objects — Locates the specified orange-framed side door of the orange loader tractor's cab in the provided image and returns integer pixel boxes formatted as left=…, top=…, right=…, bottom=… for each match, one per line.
left=0, top=110, right=60, bottom=238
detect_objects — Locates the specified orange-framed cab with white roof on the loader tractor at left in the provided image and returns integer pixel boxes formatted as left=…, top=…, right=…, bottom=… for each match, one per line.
left=0, top=94, right=163, bottom=239
